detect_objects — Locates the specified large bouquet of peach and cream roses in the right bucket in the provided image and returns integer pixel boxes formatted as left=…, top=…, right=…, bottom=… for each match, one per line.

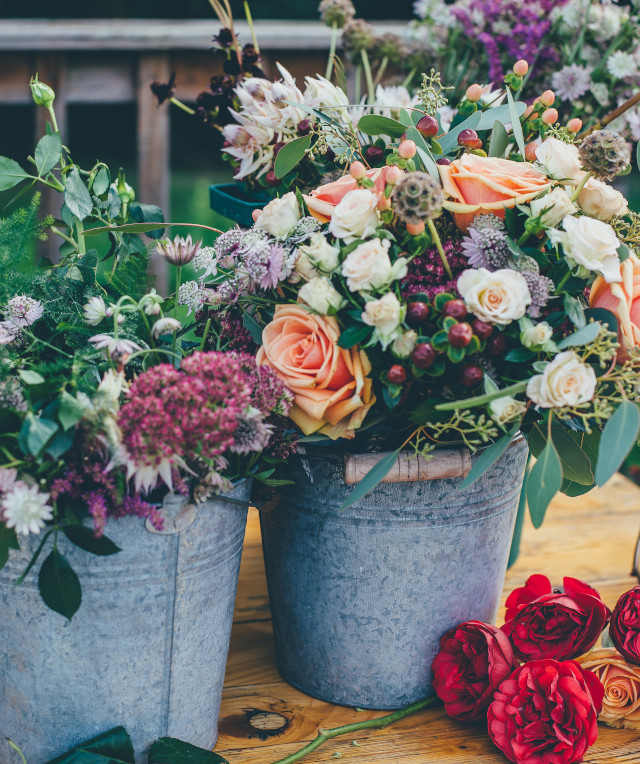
left=194, top=61, right=640, bottom=524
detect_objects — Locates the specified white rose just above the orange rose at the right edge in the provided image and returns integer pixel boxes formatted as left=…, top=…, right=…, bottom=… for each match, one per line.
left=549, top=215, right=621, bottom=284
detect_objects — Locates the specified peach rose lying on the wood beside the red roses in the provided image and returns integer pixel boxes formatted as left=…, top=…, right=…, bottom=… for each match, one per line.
left=577, top=647, right=640, bottom=730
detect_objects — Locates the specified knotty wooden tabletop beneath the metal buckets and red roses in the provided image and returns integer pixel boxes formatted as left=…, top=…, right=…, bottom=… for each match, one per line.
left=215, top=476, right=640, bottom=764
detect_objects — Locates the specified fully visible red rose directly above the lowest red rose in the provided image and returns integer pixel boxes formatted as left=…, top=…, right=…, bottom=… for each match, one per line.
left=502, top=575, right=611, bottom=661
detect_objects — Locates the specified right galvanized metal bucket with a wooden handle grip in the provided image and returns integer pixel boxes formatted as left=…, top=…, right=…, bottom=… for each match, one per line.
left=261, top=437, right=527, bottom=709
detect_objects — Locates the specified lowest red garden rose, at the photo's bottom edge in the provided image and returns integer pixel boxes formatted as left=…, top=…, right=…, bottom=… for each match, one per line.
left=488, top=660, right=604, bottom=764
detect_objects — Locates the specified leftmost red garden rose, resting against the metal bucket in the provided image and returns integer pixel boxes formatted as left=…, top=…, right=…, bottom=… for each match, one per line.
left=432, top=621, right=516, bottom=720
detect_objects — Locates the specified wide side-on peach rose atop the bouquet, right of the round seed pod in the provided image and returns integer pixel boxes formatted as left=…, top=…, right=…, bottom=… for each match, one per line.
left=438, top=154, right=553, bottom=231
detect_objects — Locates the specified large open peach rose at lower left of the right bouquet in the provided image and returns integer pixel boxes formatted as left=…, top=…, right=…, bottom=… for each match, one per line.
left=256, top=305, right=375, bottom=439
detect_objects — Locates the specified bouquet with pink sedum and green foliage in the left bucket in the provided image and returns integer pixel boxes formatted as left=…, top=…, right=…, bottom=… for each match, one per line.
left=0, top=82, right=291, bottom=618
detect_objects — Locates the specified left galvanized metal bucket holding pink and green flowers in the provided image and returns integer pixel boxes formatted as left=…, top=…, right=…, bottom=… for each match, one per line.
left=0, top=481, right=251, bottom=764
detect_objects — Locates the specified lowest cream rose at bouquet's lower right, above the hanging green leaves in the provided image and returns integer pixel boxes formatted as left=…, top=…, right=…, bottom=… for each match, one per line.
left=527, top=350, right=596, bottom=409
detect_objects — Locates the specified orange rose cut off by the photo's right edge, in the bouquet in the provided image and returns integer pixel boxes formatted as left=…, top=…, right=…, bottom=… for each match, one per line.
left=589, top=252, right=640, bottom=361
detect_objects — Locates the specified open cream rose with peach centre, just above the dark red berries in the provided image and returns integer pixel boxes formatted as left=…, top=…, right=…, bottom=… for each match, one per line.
left=457, top=268, right=531, bottom=325
